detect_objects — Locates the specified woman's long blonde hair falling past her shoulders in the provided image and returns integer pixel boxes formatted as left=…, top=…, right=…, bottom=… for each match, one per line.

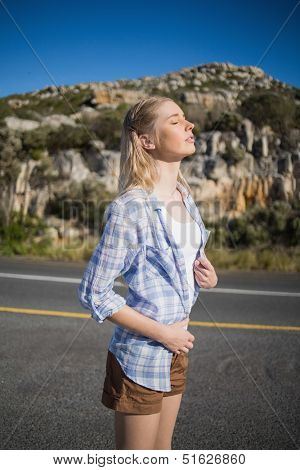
left=118, top=96, right=191, bottom=195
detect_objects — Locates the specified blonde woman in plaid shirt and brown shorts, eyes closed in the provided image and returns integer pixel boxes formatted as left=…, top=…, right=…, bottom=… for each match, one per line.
left=79, top=96, right=217, bottom=449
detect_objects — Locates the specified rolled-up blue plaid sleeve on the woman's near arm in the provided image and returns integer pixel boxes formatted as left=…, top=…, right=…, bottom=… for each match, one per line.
left=78, top=201, right=137, bottom=323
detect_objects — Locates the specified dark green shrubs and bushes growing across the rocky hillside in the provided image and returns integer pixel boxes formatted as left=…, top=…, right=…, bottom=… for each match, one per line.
left=0, top=69, right=300, bottom=270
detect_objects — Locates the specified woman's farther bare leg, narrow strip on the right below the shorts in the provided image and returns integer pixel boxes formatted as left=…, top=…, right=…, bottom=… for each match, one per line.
left=154, top=393, right=182, bottom=450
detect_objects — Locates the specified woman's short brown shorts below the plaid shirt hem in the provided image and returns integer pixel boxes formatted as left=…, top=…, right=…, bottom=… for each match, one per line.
left=101, top=350, right=188, bottom=415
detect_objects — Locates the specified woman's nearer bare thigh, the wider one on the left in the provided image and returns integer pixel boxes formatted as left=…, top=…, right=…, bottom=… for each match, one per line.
left=115, top=411, right=160, bottom=450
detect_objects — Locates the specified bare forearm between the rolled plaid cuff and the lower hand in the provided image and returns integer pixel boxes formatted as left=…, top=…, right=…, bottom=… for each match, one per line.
left=107, top=305, right=165, bottom=342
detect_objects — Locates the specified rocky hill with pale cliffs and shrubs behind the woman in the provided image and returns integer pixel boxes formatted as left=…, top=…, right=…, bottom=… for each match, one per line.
left=0, top=63, right=300, bottom=241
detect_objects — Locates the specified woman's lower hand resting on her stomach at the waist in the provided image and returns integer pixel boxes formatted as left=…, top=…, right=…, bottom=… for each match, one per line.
left=161, top=318, right=195, bottom=353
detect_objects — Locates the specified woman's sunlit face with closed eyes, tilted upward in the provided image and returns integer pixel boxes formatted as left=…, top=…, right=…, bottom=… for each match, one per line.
left=144, top=101, right=196, bottom=162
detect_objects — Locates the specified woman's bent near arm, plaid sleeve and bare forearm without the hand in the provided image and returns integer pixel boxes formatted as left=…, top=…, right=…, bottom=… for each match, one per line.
left=78, top=201, right=166, bottom=341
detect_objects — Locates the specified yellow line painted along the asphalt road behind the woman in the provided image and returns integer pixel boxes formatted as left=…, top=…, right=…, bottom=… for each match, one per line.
left=0, top=307, right=300, bottom=331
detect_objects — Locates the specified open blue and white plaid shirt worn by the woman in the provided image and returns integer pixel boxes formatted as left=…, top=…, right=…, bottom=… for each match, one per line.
left=78, top=181, right=210, bottom=391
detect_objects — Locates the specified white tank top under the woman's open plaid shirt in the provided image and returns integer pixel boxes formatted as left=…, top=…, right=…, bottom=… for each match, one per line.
left=162, top=206, right=201, bottom=308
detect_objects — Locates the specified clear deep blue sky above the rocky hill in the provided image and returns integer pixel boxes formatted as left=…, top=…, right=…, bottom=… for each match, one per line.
left=0, top=0, right=300, bottom=96
